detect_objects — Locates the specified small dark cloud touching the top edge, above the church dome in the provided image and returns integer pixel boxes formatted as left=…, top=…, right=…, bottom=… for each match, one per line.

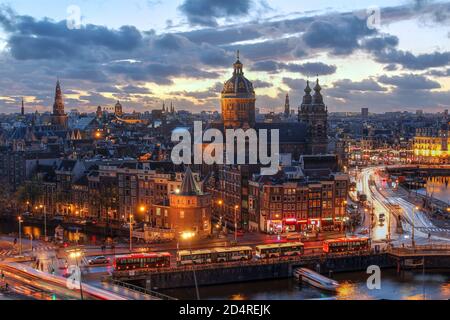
left=179, top=0, right=252, bottom=27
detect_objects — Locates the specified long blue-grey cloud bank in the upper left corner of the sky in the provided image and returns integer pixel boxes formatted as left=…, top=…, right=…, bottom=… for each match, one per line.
left=0, top=8, right=143, bottom=60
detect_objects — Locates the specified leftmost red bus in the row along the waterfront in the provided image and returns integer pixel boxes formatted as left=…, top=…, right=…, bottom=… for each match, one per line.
left=114, top=252, right=171, bottom=271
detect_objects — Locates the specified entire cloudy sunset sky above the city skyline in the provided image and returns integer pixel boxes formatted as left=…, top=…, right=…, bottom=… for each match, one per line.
left=0, top=0, right=450, bottom=113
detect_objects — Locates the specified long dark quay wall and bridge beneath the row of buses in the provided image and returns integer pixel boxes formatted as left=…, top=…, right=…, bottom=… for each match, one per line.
left=112, top=246, right=450, bottom=290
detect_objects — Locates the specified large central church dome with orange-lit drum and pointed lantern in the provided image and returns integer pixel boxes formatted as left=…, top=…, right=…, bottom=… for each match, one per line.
left=221, top=51, right=256, bottom=129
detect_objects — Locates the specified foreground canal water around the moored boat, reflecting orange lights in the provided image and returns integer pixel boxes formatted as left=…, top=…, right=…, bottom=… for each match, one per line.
left=164, top=270, right=450, bottom=300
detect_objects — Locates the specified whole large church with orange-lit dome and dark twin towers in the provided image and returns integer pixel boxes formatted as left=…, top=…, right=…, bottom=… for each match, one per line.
left=213, top=51, right=328, bottom=159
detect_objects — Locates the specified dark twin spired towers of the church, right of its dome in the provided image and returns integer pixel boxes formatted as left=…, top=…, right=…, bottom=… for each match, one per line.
left=299, top=79, right=328, bottom=154
